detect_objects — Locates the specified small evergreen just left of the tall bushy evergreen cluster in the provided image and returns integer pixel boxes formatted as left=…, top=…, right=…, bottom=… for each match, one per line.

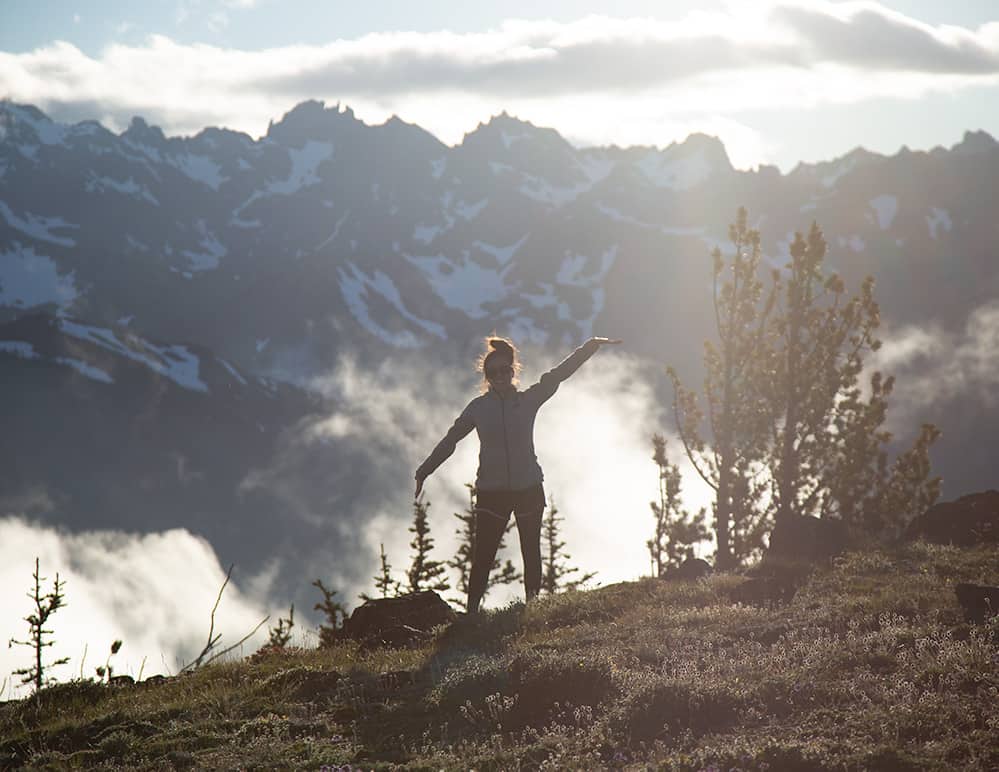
left=645, top=434, right=709, bottom=576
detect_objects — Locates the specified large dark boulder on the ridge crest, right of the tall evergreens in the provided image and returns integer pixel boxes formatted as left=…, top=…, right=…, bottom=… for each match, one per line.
left=905, top=490, right=999, bottom=547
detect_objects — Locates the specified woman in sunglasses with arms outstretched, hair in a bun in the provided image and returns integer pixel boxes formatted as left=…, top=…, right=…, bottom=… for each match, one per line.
left=416, top=338, right=621, bottom=613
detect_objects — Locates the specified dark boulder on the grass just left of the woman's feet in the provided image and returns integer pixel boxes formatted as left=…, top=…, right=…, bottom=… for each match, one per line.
left=343, top=590, right=457, bottom=646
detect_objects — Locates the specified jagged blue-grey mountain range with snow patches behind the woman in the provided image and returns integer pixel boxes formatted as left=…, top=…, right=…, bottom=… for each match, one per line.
left=0, top=95, right=999, bottom=604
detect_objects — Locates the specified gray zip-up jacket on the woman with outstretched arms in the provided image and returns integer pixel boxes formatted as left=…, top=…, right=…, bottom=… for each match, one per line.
left=416, top=340, right=600, bottom=491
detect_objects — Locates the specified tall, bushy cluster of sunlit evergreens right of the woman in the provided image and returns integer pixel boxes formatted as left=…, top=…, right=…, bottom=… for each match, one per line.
left=668, top=209, right=940, bottom=568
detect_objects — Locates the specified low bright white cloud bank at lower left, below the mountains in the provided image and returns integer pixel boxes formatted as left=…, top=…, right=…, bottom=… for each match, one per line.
left=0, top=515, right=278, bottom=699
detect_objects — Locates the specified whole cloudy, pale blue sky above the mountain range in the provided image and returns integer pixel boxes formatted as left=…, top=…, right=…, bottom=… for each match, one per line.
left=0, top=0, right=999, bottom=172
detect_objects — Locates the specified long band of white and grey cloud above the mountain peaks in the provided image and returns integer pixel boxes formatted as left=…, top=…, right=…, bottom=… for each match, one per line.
left=0, top=2, right=999, bottom=166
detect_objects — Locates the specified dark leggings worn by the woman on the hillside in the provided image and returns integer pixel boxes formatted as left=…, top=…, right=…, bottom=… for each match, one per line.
left=468, top=485, right=545, bottom=613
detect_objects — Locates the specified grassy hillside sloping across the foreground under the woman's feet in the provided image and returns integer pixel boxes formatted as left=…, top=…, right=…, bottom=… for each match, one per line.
left=0, top=544, right=999, bottom=770
